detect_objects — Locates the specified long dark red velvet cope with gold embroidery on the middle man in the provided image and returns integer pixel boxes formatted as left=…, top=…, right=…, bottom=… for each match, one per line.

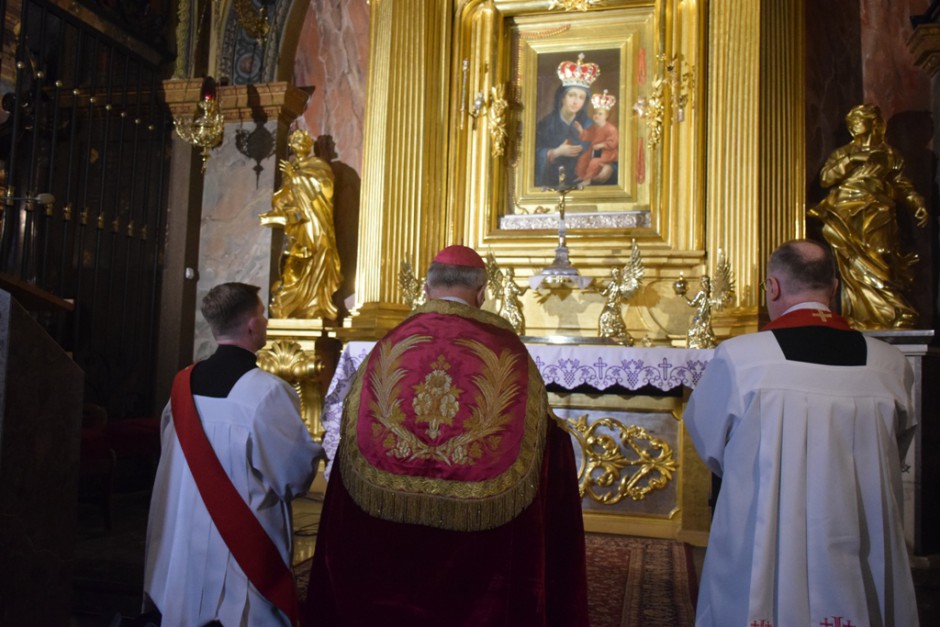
left=303, top=301, right=588, bottom=627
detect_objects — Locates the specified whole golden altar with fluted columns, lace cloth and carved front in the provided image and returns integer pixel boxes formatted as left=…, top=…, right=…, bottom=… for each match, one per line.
left=258, top=0, right=804, bottom=544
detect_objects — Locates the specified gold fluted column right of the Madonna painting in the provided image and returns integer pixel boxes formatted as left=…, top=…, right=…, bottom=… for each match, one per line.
left=706, top=0, right=806, bottom=335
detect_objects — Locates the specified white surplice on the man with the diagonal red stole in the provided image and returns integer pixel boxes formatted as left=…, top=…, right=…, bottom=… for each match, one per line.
left=144, top=368, right=322, bottom=627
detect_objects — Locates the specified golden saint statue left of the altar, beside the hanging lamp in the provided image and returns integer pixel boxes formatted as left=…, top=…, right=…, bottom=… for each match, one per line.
left=260, top=130, right=343, bottom=320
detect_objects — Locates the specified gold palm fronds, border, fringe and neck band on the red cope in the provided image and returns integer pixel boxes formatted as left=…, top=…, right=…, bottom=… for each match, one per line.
left=337, top=300, right=549, bottom=531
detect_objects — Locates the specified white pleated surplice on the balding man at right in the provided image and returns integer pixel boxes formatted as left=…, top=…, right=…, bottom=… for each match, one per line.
left=684, top=331, right=918, bottom=627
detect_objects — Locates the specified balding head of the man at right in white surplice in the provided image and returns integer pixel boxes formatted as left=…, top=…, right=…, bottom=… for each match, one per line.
left=766, top=239, right=839, bottom=320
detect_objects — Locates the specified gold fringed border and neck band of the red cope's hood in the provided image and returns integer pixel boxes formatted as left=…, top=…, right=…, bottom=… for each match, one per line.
left=339, top=301, right=549, bottom=531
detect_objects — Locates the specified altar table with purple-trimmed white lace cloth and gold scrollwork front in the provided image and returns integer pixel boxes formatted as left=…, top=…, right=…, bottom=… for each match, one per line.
left=321, top=341, right=712, bottom=546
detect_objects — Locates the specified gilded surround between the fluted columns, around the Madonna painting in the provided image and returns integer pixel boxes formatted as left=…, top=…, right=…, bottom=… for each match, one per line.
left=449, top=0, right=705, bottom=265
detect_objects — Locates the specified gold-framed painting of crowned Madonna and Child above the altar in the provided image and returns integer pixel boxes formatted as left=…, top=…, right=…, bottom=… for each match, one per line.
left=500, top=6, right=656, bottom=223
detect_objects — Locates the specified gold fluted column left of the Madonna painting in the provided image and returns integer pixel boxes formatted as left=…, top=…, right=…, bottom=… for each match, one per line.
left=345, top=0, right=454, bottom=338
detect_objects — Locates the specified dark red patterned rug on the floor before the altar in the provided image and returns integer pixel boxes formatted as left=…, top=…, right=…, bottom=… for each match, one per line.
left=294, top=533, right=698, bottom=627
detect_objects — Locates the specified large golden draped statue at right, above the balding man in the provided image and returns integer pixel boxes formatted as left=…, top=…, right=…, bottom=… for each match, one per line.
left=809, top=104, right=927, bottom=329
